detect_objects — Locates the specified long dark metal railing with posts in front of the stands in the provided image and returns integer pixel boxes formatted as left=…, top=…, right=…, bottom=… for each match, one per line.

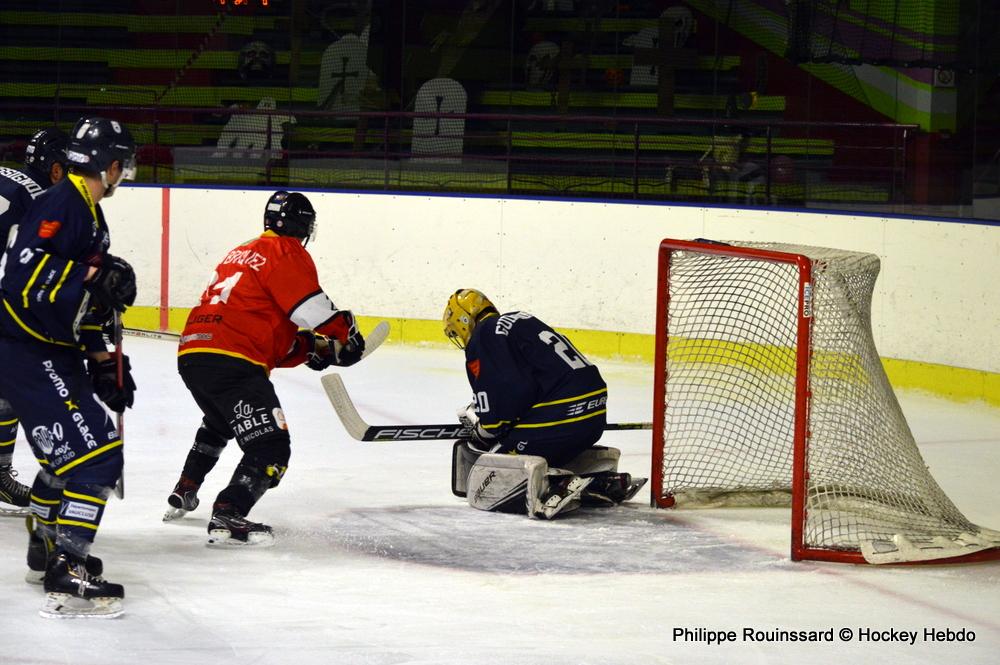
left=0, top=100, right=918, bottom=212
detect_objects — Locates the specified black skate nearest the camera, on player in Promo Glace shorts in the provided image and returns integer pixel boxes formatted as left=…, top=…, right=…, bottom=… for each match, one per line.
left=39, top=552, right=125, bottom=619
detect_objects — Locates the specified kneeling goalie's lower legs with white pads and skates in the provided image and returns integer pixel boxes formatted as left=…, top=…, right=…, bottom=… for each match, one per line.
left=451, top=441, right=646, bottom=519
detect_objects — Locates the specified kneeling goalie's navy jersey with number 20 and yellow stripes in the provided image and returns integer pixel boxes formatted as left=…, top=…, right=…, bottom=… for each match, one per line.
left=465, top=312, right=608, bottom=437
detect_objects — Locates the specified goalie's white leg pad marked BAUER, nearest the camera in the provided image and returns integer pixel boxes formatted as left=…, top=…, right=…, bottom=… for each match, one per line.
left=467, top=453, right=549, bottom=517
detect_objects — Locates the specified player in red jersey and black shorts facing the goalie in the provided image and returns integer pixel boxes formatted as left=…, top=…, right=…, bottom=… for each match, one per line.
left=163, top=191, right=365, bottom=546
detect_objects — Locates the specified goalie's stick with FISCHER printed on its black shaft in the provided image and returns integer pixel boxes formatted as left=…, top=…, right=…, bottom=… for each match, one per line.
left=320, top=372, right=653, bottom=441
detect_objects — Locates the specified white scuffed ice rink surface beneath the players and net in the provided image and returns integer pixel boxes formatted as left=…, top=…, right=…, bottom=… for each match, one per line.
left=0, top=337, right=1000, bottom=665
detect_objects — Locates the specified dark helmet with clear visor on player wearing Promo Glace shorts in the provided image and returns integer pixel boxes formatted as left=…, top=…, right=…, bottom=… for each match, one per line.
left=66, top=117, right=135, bottom=196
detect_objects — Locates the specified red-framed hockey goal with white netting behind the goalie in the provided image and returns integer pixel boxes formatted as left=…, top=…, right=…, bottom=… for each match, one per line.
left=652, top=240, right=1000, bottom=563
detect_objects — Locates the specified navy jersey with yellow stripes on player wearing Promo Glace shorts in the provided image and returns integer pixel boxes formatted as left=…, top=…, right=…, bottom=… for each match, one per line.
left=0, top=174, right=110, bottom=349
